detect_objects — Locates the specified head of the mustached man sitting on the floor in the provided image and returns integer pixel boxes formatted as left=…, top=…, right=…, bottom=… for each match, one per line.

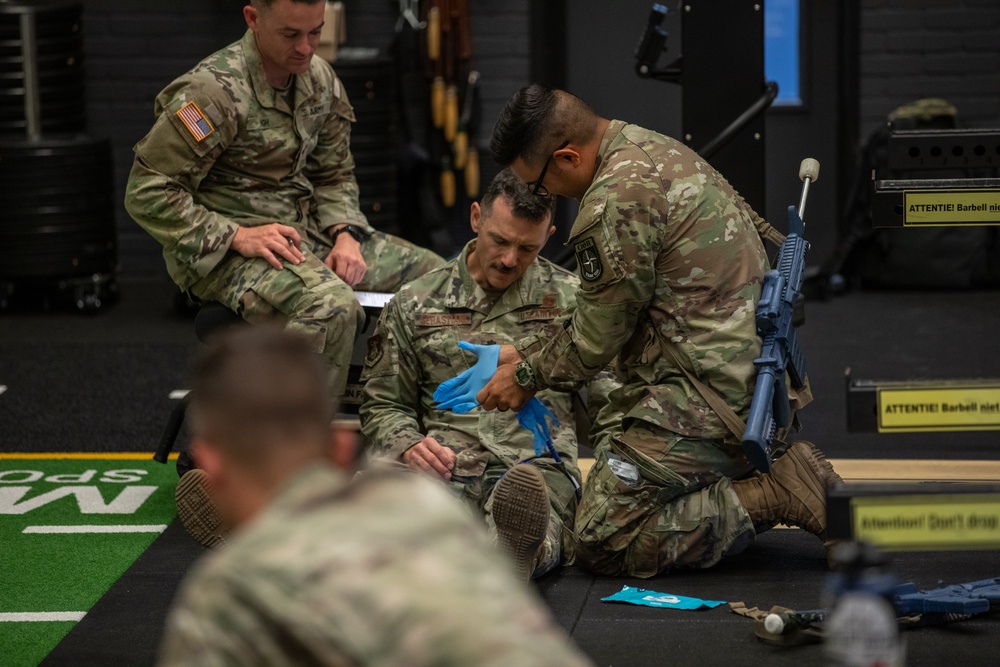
left=468, top=169, right=556, bottom=290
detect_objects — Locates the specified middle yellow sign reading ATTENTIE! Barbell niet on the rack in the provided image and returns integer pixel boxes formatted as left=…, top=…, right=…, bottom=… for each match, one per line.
left=876, top=384, right=1000, bottom=432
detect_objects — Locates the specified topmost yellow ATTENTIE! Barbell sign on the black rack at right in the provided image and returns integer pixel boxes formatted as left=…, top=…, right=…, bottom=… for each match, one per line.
left=903, top=190, right=1000, bottom=226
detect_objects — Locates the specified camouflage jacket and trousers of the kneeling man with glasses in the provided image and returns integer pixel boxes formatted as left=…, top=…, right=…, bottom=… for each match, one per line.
left=528, top=121, right=770, bottom=577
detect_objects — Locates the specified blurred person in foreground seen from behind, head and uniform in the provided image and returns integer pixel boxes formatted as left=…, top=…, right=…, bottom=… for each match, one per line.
left=160, top=326, right=589, bottom=667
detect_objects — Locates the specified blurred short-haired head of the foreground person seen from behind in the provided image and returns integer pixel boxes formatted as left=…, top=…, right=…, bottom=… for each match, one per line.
left=190, top=325, right=356, bottom=526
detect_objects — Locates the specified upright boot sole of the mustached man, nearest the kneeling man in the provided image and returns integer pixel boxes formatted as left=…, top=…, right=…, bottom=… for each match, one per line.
left=493, top=464, right=549, bottom=581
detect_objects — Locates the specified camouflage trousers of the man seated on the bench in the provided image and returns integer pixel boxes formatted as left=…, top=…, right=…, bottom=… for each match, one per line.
left=191, top=232, right=444, bottom=396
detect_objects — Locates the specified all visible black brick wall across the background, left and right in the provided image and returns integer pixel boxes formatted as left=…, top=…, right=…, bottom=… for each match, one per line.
left=62, top=0, right=1000, bottom=273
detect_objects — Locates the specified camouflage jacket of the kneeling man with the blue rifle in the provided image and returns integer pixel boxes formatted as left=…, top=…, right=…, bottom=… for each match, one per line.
left=529, top=121, right=771, bottom=441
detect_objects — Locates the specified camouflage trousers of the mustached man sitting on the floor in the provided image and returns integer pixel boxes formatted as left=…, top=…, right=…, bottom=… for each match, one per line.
left=450, top=456, right=576, bottom=578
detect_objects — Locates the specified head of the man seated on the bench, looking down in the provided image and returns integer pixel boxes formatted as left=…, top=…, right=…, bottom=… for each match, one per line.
left=243, top=0, right=326, bottom=87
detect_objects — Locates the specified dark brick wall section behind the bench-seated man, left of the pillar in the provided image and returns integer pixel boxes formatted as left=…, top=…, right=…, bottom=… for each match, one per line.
left=76, top=0, right=529, bottom=273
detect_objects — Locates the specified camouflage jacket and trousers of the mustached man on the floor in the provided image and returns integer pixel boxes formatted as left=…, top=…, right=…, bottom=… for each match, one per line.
left=360, top=241, right=621, bottom=576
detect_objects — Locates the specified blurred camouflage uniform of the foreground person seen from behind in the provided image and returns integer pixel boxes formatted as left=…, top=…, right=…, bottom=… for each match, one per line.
left=160, top=465, right=590, bottom=667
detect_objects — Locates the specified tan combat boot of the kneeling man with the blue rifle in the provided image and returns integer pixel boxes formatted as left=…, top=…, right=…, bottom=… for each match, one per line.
left=733, top=442, right=840, bottom=544
